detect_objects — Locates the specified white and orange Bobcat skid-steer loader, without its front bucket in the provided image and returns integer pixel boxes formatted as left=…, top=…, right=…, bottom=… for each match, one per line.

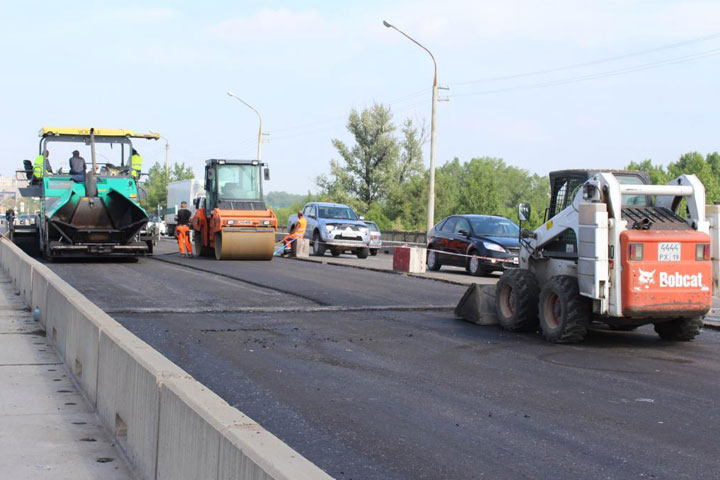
left=495, top=170, right=717, bottom=342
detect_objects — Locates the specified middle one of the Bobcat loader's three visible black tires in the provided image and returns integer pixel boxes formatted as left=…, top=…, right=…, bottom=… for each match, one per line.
left=538, top=275, right=592, bottom=343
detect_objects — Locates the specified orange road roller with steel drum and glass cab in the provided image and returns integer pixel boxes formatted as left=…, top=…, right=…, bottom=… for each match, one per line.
left=192, top=159, right=277, bottom=260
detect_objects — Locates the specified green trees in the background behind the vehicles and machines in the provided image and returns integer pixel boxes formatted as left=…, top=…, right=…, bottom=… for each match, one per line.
left=138, top=104, right=720, bottom=231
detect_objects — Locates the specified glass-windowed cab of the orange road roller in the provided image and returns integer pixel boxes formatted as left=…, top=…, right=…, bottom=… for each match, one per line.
left=205, top=159, right=269, bottom=211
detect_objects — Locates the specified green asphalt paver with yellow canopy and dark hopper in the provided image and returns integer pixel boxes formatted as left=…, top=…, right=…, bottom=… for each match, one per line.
left=10, top=127, right=160, bottom=258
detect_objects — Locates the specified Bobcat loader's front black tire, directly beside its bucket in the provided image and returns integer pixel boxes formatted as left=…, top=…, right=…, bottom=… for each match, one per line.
left=495, top=270, right=540, bottom=332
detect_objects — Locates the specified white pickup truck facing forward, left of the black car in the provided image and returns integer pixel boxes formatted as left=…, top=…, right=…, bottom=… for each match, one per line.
left=287, top=202, right=370, bottom=258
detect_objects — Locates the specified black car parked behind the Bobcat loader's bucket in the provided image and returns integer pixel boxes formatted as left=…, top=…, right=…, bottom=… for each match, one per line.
left=427, top=215, right=520, bottom=276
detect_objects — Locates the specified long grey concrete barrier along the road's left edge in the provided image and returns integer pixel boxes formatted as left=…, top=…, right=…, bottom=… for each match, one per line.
left=0, top=238, right=331, bottom=480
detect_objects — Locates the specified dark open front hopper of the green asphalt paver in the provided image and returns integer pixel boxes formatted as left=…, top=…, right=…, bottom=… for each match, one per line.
left=49, top=190, right=148, bottom=245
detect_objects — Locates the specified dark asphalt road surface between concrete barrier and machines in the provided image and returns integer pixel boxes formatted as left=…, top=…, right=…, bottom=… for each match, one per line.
left=49, top=248, right=720, bottom=480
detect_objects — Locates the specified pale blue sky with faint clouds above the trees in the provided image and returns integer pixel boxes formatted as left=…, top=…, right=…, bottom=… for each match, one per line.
left=0, top=0, right=720, bottom=193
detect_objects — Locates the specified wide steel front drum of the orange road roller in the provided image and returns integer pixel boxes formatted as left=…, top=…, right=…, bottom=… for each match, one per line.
left=215, top=227, right=275, bottom=260
